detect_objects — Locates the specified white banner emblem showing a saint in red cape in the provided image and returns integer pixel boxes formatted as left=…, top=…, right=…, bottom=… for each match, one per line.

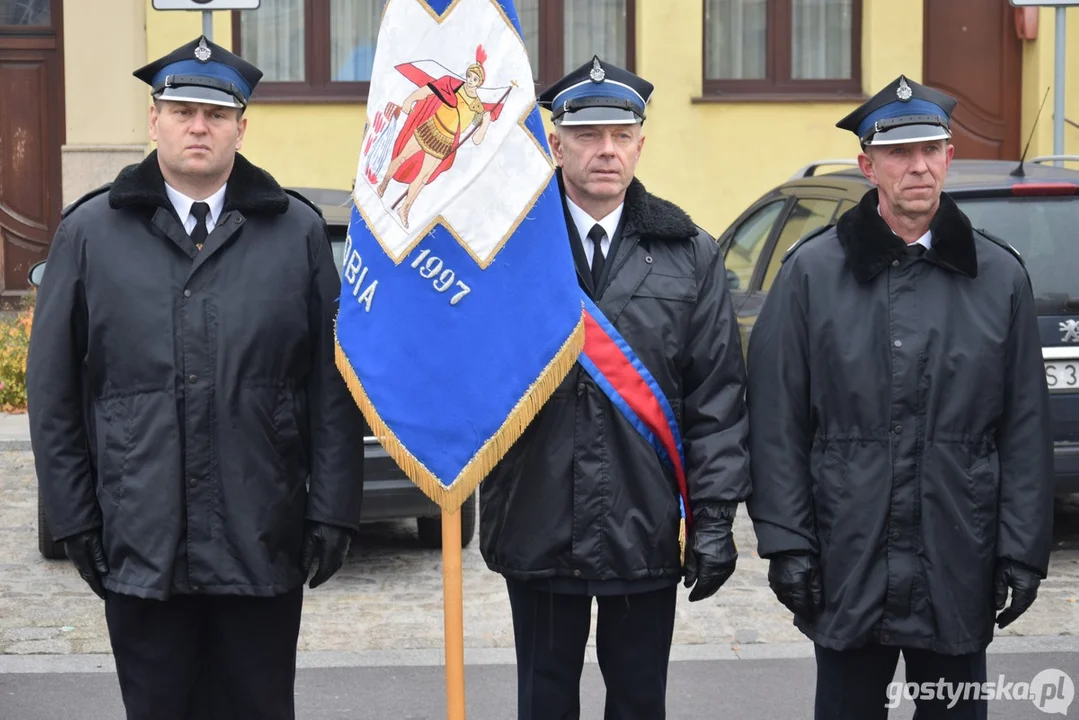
left=354, top=0, right=552, bottom=268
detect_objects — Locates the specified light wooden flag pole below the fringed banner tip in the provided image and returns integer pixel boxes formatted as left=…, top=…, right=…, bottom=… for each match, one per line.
left=442, top=508, right=465, bottom=720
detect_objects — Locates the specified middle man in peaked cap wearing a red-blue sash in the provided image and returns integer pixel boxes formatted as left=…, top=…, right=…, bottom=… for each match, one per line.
left=480, top=57, right=750, bottom=720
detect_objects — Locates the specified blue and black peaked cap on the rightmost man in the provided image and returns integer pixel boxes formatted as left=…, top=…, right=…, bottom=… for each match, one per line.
left=835, top=76, right=958, bottom=147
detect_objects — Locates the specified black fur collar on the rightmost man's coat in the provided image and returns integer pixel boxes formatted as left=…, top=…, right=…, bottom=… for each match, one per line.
left=836, top=188, right=978, bottom=283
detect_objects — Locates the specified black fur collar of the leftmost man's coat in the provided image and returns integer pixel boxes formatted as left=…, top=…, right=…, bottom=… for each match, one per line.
left=109, top=150, right=288, bottom=214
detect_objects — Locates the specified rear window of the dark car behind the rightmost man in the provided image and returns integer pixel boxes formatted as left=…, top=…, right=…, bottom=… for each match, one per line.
left=956, top=195, right=1079, bottom=313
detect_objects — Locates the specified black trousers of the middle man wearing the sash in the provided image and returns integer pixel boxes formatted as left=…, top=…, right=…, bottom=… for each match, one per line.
left=506, top=581, right=678, bottom=720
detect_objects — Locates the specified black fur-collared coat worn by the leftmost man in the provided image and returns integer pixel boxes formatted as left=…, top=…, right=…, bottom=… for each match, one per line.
left=27, top=152, right=363, bottom=599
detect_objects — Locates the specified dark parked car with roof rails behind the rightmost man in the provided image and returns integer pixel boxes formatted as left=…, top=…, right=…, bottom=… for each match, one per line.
left=719, top=158, right=1079, bottom=493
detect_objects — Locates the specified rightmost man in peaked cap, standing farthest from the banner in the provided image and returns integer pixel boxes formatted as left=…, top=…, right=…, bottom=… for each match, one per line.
left=748, top=77, right=1053, bottom=720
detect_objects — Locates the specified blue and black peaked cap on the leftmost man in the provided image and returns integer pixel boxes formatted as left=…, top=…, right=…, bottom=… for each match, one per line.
left=132, top=36, right=262, bottom=108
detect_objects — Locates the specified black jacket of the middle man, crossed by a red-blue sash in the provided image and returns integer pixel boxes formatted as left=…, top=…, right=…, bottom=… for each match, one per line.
left=480, top=172, right=750, bottom=583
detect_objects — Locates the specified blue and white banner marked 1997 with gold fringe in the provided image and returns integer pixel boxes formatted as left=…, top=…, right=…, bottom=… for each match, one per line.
left=337, top=0, right=584, bottom=511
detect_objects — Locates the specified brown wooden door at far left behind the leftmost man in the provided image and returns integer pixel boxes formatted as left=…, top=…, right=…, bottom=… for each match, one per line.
left=0, top=0, right=65, bottom=305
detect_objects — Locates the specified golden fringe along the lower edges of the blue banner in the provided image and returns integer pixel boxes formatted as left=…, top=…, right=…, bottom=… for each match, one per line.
left=333, top=310, right=585, bottom=513
